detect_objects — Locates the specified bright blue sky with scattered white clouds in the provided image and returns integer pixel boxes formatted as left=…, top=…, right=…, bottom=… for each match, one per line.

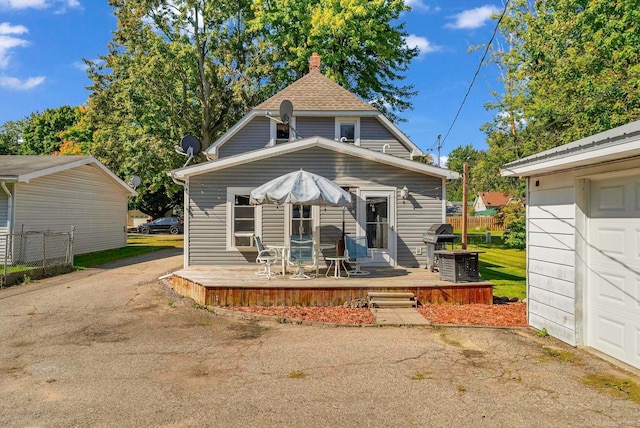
left=0, top=0, right=501, bottom=158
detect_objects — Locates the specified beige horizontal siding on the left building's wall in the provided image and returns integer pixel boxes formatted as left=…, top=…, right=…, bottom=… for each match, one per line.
left=14, top=165, right=128, bottom=254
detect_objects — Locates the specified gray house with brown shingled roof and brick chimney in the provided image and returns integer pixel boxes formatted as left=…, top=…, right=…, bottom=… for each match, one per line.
left=171, top=51, right=458, bottom=268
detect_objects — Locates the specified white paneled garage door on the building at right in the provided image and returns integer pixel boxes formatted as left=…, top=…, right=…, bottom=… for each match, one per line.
left=586, top=177, right=640, bottom=368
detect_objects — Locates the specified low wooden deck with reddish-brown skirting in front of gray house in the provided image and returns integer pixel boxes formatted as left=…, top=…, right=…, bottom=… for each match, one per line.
left=172, top=266, right=493, bottom=306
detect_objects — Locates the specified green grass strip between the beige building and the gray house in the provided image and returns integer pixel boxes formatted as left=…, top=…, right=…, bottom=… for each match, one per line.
left=74, top=234, right=184, bottom=269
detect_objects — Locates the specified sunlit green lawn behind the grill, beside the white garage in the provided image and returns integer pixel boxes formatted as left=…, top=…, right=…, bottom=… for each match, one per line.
left=464, top=236, right=527, bottom=299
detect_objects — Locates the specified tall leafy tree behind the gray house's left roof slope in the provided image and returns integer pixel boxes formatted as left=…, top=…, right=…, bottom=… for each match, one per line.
left=89, top=0, right=260, bottom=217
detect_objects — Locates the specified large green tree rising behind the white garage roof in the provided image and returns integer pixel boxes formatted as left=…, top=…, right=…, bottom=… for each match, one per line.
left=473, top=0, right=640, bottom=195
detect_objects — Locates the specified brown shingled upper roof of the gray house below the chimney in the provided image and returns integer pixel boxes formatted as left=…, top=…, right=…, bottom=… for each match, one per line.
left=255, top=70, right=378, bottom=111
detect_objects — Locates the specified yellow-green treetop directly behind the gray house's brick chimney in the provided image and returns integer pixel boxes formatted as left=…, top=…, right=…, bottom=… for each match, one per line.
left=250, top=0, right=418, bottom=121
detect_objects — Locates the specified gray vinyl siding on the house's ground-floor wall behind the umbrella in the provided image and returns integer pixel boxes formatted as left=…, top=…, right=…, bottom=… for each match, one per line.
left=187, top=147, right=443, bottom=267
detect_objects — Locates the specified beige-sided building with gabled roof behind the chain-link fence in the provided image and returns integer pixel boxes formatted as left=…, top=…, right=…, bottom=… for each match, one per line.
left=0, top=156, right=136, bottom=257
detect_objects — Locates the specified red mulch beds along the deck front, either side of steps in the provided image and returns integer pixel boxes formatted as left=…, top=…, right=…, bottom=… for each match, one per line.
left=228, top=302, right=527, bottom=327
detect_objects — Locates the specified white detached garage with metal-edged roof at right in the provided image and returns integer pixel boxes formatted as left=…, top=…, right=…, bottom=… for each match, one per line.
left=501, top=121, right=640, bottom=368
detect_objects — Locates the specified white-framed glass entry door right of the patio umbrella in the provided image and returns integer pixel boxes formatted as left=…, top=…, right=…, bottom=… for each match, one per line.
left=357, top=189, right=396, bottom=266
